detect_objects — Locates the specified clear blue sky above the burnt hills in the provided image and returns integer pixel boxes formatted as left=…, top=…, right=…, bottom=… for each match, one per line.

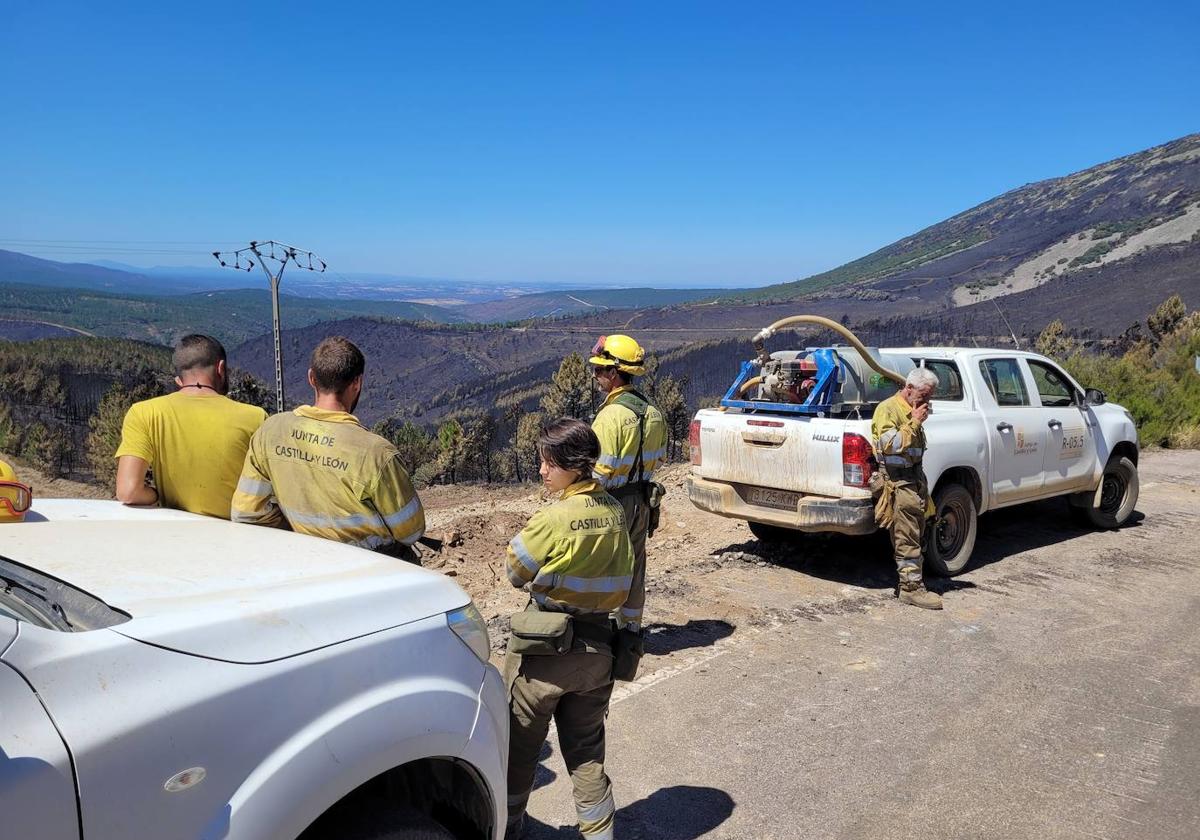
left=0, top=0, right=1200, bottom=286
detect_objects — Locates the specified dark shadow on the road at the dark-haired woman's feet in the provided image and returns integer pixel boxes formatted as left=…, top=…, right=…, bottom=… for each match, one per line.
left=522, top=785, right=734, bottom=840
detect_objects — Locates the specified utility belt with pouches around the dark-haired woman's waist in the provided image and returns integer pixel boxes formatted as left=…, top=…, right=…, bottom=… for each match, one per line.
left=509, top=601, right=644, bottom=680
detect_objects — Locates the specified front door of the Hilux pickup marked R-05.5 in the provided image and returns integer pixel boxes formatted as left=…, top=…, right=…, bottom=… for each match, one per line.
left=1025, top=359, right=1096, bottom=493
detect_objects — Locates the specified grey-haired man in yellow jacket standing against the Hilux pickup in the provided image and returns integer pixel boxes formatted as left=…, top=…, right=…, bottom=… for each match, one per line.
left=871, top=367, right=942, bottom=610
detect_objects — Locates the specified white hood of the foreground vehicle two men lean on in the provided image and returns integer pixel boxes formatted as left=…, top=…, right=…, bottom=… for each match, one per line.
left=0, top=499, right=470, bottom=662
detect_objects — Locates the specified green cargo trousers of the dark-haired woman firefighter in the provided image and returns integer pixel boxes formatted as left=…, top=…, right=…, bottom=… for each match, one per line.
left=504, top=650, right=616, bottom=840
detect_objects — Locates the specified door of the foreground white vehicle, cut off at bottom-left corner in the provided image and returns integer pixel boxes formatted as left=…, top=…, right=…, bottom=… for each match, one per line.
left=0, top=619, right=79, bottom=840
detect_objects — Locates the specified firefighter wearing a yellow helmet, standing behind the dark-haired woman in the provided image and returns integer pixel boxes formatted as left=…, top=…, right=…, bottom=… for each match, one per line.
left=588, top=335, right=667, bottom=630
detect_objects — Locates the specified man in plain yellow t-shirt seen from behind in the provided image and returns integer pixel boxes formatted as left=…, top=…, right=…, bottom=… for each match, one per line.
left=116, top=335, right=266, bottom=520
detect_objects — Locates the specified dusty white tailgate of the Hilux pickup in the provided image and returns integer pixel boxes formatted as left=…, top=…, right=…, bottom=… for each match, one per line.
left=692, top=410, right=870, bottom=498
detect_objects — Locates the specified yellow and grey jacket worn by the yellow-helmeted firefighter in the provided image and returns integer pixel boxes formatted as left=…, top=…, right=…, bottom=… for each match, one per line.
left=592, top=386, right=667, bottom=490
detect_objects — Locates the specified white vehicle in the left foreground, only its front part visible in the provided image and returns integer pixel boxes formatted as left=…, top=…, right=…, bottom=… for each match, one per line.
left=0, top=499, right=509, bottom=840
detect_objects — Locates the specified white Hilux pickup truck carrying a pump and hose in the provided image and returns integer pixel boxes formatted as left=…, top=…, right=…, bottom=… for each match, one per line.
left=688, top=347, right=1138, bottom=575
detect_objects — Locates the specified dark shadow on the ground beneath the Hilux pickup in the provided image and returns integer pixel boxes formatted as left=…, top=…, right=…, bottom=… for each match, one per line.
left=714, top=498, right=1146, bottom=592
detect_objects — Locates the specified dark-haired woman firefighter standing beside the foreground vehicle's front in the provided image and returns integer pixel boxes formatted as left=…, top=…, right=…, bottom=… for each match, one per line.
left=504, top=418, right=634, bottom=840
